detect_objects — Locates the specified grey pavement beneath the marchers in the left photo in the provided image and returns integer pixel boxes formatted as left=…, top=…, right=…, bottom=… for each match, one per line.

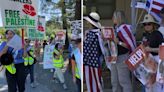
left=0, top=51, right=77, bottom=92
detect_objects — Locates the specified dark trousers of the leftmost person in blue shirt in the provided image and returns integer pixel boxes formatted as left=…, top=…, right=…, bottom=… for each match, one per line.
left=6, top=63, right=26, bottom=92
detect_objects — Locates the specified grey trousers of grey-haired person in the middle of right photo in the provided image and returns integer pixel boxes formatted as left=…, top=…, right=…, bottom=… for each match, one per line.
left=111, top=54, right=132, bottom=92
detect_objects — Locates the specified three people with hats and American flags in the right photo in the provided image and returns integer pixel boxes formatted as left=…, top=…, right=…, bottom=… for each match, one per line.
left=83, top=8, right=164, bottom=92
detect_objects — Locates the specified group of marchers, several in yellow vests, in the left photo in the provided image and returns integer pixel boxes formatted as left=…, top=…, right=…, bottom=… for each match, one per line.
left=0, top=30, right=82, bottom=92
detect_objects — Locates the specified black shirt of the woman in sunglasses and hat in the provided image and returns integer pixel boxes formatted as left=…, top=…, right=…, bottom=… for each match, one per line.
left=143, top=31, right=163, bottom=55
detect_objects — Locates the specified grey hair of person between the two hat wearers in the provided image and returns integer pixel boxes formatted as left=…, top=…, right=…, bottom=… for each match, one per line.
left=113, top=10, right=127, bottom=26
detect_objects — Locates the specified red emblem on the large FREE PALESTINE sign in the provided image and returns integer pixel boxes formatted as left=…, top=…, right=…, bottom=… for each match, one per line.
left=22, top=4, right=36, bottom=16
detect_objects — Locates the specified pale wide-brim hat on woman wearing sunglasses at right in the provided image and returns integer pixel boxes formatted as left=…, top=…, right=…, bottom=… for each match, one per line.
left=141, top=14, right=159, bottom=25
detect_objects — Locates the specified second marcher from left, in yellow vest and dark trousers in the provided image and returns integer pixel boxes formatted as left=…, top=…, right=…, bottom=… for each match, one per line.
left=24, top=39, right=36, bottom=88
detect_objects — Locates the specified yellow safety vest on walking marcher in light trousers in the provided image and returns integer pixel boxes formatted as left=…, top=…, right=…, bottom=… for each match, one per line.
left=53, top=55, right=64, bottom=68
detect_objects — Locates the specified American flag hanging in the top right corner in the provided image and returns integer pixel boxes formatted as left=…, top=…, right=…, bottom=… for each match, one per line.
left=146, top=0, right=164, bottom=22
